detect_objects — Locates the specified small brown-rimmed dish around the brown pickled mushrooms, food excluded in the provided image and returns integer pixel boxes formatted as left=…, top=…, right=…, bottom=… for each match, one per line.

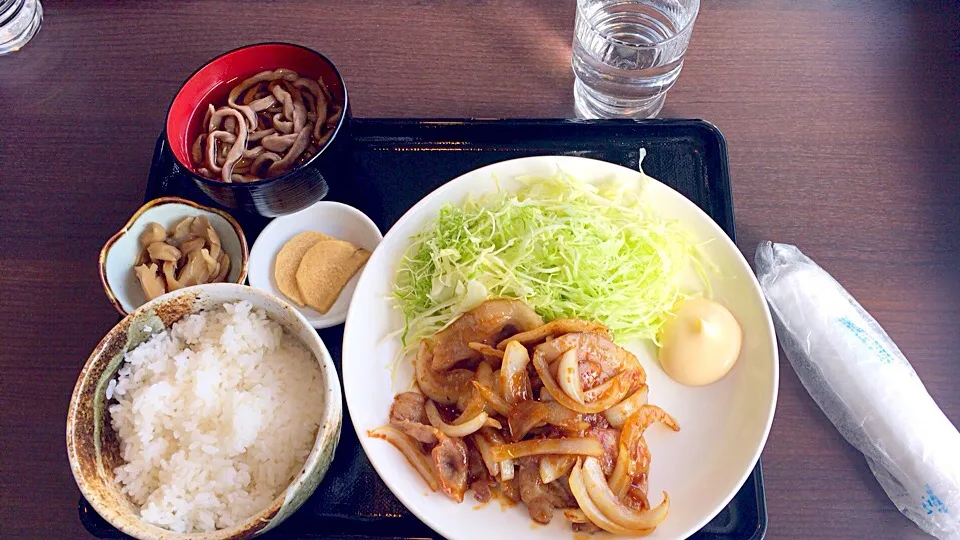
left=99, top=197, right=249, bottom=315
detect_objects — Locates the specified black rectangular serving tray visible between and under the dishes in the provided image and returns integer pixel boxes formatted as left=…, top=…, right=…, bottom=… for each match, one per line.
left=80, top=119, right=767, bottom=540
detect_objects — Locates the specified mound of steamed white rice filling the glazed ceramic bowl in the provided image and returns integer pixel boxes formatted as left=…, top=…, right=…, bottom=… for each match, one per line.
left=107, top=301, right=323, bottom=532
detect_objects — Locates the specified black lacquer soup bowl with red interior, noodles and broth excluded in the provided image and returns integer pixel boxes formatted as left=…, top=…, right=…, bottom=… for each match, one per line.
left=166, top=43, right=351, bottom=217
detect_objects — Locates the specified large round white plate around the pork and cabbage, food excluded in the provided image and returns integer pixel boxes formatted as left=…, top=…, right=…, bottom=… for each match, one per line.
left=343, top=156, right=778, bottom=540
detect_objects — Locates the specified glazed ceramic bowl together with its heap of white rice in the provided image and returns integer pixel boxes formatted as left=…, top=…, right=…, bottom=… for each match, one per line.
left=67, top=283, right=342, bottom=540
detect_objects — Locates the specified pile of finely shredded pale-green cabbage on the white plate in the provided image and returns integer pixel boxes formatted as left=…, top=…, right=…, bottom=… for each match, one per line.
left=394, top=166, right=707, bottom=350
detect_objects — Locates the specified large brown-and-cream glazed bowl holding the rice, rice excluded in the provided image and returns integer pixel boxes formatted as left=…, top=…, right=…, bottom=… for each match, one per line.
left=66, top=283, right=343, bottom=540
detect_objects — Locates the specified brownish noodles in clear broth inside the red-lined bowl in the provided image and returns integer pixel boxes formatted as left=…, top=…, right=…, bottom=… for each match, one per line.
left=191, top=69, right=343, bottom=182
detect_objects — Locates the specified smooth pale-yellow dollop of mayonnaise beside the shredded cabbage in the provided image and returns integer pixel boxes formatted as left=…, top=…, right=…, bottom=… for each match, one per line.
left=659, top=298, right=743, bottom=386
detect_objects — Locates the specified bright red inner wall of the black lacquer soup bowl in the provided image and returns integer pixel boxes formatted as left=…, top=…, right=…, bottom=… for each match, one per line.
left=167, top=43, right=344, bottom=177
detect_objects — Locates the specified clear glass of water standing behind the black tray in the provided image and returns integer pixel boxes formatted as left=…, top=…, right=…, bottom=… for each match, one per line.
left=572, top=0, right=700, bottom=119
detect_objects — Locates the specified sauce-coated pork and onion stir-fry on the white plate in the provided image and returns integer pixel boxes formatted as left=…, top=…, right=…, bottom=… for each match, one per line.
left=369, top=299, right=680, bottom=536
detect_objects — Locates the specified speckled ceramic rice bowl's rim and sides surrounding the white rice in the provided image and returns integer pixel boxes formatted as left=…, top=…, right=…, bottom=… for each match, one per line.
left=66, top=283, right=343, bottom=540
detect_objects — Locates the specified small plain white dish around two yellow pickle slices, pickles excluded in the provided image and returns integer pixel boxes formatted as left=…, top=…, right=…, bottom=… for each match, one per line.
left=250, top=201, right=383, bottom=328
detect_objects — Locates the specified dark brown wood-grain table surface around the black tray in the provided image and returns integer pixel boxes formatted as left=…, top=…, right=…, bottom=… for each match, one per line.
left=0, top=0, right=960, bottom=538
